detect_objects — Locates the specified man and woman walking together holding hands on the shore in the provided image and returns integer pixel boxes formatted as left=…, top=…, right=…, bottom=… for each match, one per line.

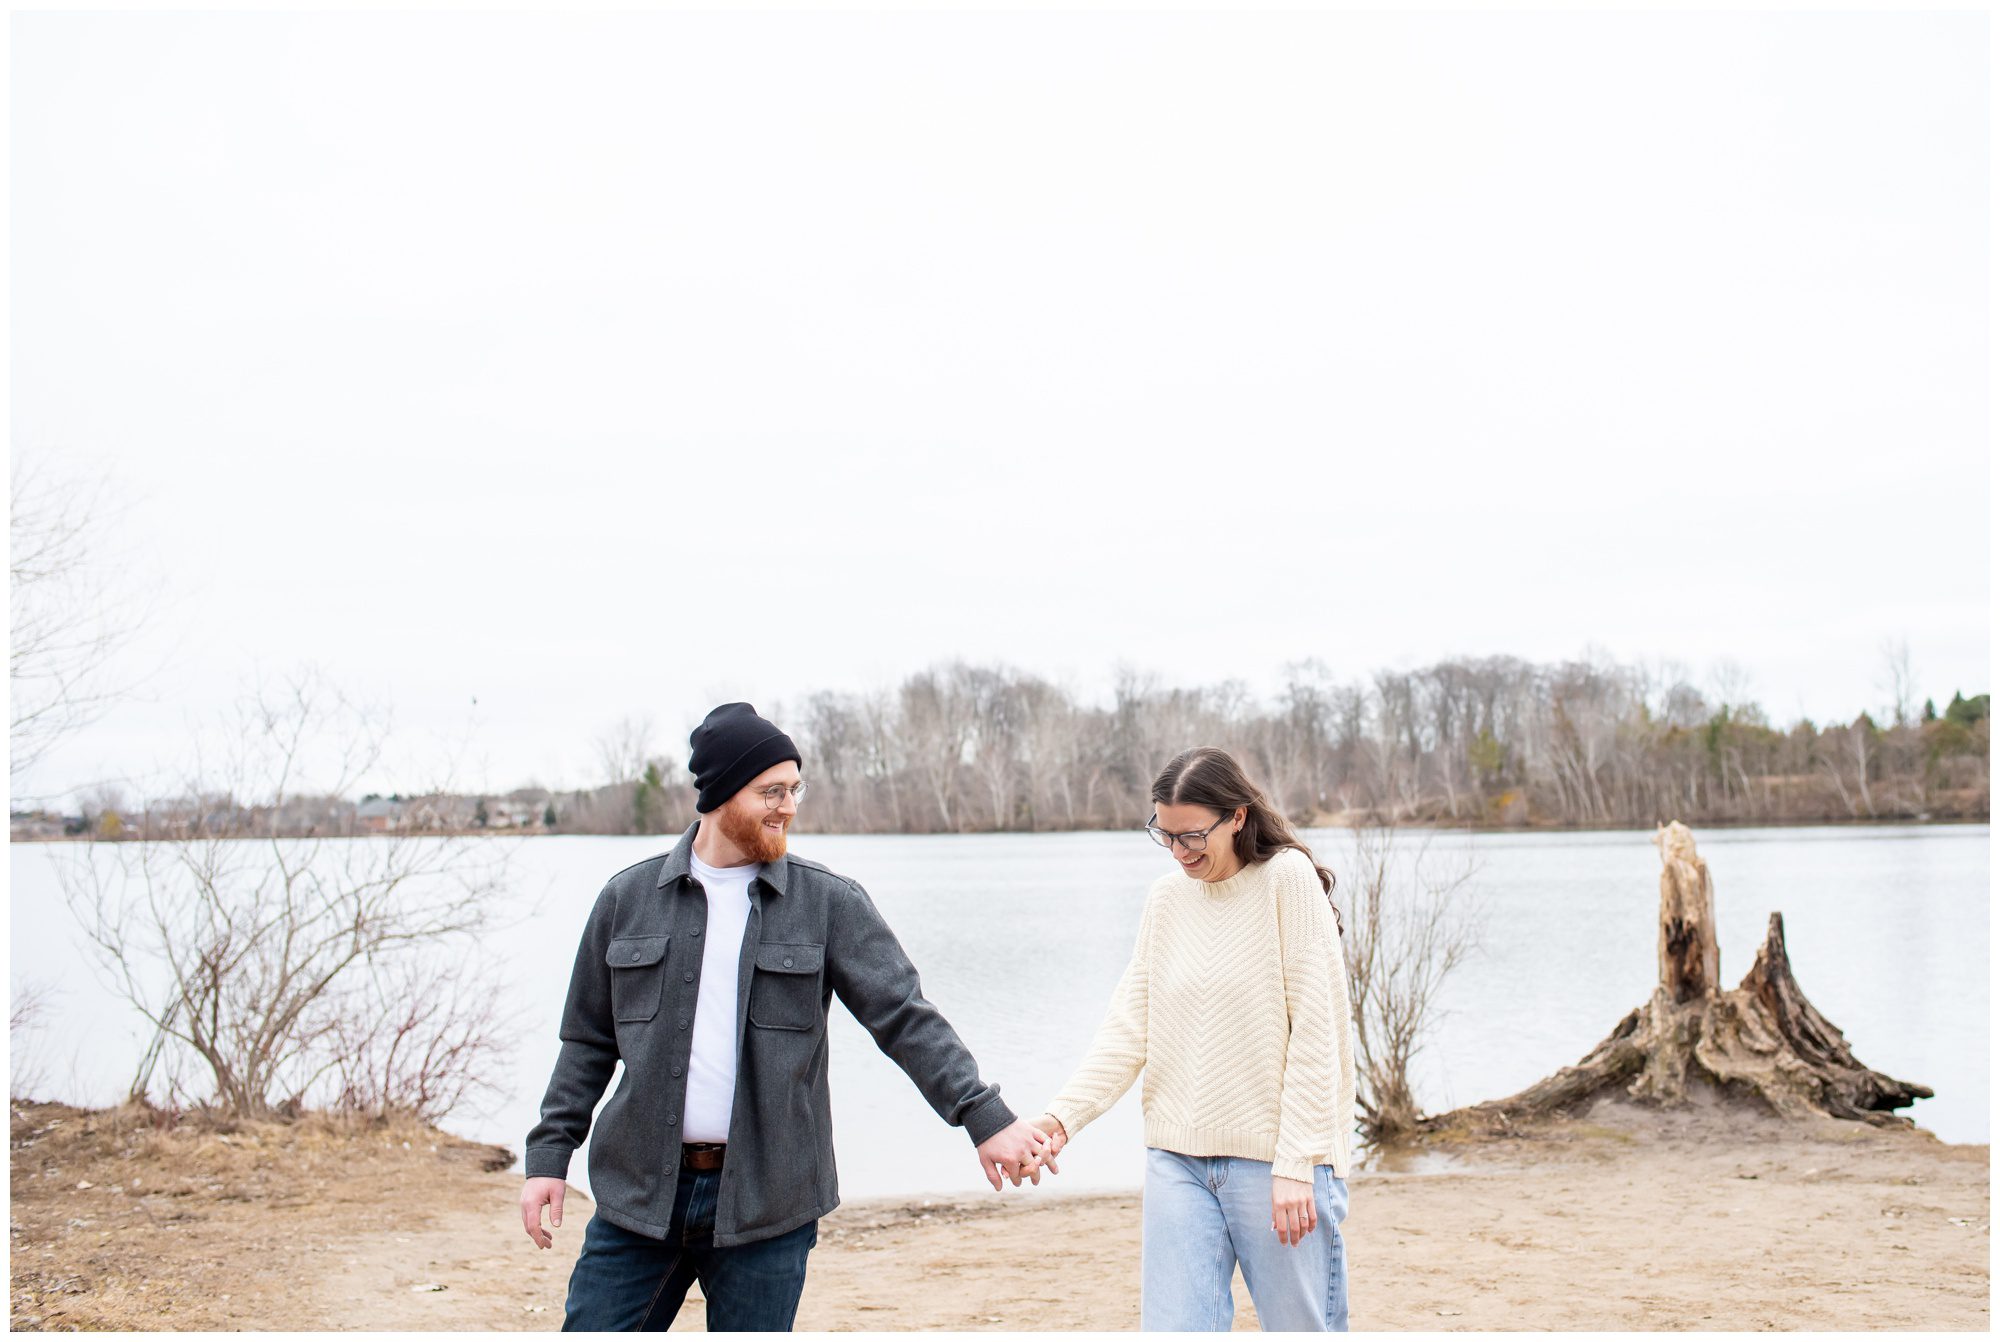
left=520, top=704, right=1354, bottom=1332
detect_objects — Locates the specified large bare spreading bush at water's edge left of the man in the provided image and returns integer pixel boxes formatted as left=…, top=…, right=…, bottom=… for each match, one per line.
left=58, top=672, right=508, bottom=1116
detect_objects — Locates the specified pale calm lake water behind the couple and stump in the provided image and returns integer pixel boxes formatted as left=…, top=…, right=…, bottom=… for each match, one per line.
left=10, top=826, right=1990, bottom=1198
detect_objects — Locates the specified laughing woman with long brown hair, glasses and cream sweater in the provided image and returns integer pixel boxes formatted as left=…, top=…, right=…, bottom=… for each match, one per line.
left=1036, top=748, right=1354, bottom=1332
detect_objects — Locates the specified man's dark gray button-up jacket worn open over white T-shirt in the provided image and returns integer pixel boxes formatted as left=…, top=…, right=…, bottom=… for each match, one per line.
left=524, top=828, right=1014, bottom=1248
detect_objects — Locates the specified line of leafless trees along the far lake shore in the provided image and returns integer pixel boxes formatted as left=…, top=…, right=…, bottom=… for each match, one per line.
left=552, top=656, right=1990, bottom=834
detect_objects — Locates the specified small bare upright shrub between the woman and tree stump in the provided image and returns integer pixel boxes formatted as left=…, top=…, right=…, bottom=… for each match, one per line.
left=1342, top=826, right=1480, bottom=1142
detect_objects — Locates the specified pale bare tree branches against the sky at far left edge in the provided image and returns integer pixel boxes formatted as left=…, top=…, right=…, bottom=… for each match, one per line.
left=6, top=452, right=150, bottom=798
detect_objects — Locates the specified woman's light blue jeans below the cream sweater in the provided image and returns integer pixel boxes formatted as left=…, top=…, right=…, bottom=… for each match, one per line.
left=1138, top=1146, right=1348, bottom=1332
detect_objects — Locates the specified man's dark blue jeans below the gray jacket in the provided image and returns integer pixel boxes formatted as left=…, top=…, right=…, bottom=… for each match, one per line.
left=562, top=1166, right=820, bottom=1332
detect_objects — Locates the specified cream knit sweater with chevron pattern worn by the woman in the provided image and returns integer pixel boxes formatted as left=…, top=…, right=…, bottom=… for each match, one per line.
left=1048, top=848, right=1354, bottom=1182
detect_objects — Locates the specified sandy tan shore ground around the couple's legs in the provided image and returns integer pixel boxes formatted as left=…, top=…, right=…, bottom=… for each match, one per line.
left=10, top=1106, right=1990, bottom=1332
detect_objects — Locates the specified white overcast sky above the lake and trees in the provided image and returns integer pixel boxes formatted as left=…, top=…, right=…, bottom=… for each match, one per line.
left=12, top=14, right=1992, bottom=792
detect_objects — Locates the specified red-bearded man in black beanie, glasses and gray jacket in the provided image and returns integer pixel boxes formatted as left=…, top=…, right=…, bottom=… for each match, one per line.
left=520, top=704, right=1056, bottom=1332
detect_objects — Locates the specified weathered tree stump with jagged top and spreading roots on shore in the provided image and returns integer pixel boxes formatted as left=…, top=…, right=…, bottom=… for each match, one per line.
left=1420, top=822, right=1932, bottom=1132
